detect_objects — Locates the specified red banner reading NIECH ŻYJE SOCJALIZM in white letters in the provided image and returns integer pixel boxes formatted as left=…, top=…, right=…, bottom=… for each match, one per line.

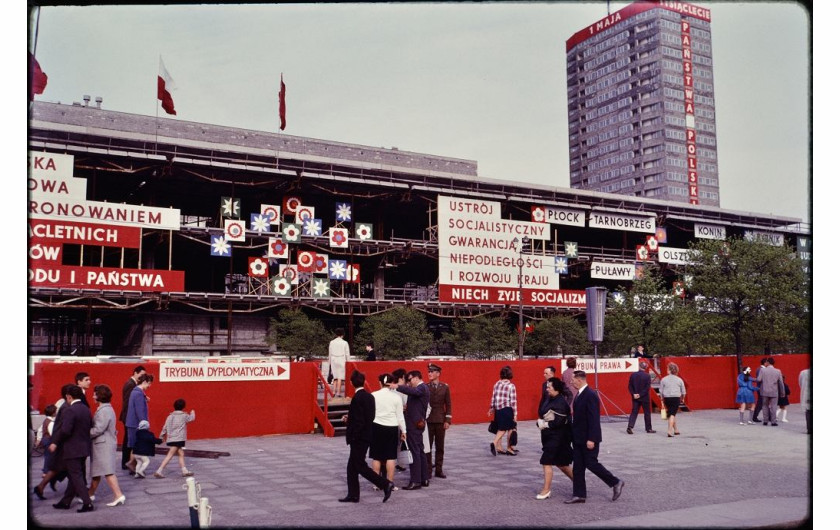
left=438, top=284, right=586, bottom=308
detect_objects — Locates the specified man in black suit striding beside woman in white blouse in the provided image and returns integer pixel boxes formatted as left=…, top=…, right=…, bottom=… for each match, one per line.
left=338, top=370, right=394, bottom=502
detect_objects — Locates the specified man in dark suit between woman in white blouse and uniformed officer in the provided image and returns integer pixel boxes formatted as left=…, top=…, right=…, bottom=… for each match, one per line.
left=397, top=370, right=431, bottom=491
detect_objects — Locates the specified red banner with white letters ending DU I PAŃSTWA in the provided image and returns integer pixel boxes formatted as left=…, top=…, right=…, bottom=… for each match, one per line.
left=29, top=261, right=184, bottom=293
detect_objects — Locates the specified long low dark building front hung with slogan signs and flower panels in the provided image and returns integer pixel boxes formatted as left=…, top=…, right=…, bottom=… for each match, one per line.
left=28, top=102, right=810, bottom=355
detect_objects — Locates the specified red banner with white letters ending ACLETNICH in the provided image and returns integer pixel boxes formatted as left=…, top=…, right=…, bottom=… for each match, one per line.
left=29, top=219, right=141, bottom=248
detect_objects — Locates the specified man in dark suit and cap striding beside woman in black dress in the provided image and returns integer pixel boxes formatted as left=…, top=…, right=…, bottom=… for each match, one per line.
left=564, top=370, right=624, bottom=504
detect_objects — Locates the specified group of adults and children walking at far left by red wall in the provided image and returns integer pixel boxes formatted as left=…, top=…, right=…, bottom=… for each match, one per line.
left=33, top=366, right=195, bottom=512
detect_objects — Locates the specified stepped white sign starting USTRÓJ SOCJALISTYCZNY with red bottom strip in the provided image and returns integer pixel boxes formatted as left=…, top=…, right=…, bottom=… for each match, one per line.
left=438, top=195, right=586, bottom=308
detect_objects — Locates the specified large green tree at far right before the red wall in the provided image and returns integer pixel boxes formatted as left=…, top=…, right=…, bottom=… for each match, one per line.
left=687, top=238, right=808, bottom=370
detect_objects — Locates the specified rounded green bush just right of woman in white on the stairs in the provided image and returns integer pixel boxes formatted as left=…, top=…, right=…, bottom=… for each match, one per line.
left=354, top=307, right=434, bottom=360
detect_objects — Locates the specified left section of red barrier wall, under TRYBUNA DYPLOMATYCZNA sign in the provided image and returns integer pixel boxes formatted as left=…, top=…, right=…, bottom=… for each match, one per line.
left=30, top=360, right=318, bottom=441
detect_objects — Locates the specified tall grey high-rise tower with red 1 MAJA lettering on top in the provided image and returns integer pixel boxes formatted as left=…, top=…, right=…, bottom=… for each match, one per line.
left=566, top=0, right=720, bottom=206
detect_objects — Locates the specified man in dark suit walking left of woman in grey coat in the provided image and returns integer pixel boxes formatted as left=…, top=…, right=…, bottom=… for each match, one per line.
left=49, top=385, right=93, bottom=512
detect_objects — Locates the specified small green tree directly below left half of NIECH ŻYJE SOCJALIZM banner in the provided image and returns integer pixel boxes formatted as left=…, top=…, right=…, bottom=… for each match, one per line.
left=444, top=315, right=517, bottom=359
